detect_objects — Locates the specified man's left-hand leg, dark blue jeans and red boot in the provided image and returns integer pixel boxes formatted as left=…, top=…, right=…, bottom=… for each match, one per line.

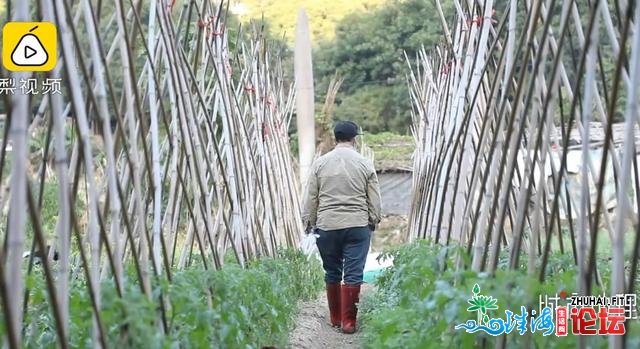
left=316, top=229, right=343, bottom=327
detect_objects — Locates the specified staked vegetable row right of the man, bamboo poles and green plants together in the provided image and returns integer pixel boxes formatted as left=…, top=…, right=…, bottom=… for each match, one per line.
left=363, top=1, right=640, bottom=348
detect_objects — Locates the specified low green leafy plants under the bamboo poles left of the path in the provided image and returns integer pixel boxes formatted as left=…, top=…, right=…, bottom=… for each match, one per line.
left=13, top=246, right=323, bottom=348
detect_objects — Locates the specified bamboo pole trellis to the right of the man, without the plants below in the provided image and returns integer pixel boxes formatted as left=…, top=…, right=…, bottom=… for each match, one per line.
left=408, top=0, right=640, bottom=348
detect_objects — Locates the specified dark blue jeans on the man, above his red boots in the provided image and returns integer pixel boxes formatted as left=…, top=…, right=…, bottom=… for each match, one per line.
left=316, top=227, right=371, bottom=285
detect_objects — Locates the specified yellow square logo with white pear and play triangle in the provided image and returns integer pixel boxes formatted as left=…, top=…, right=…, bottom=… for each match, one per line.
left=2, top=22, right=57, bottom=71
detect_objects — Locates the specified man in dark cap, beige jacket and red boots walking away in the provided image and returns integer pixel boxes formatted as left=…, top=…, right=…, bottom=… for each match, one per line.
left=302, top=121, right=380, bottom=333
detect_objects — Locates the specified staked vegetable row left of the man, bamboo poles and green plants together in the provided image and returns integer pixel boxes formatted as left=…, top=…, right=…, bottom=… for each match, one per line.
left=0, top=0, right=314, bottom=348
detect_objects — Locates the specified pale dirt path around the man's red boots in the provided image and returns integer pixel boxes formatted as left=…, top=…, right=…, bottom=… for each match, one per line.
left=289, top=284, right=373, bottom=349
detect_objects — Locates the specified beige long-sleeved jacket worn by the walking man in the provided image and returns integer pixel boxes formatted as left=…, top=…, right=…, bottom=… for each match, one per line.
left=302, top=144, right=381, bottom=230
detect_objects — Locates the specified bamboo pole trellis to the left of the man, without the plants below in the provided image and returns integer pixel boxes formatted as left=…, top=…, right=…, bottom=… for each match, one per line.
left=0, top=0, right=302, bottom=348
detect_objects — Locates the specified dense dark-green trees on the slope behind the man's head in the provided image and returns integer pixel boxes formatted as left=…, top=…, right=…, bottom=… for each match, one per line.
left=313, top=0, right=455, bottom=133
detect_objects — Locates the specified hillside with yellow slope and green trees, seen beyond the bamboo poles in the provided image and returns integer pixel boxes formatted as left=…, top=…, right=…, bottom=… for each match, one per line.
left=238, top=0, right=626, bottom=134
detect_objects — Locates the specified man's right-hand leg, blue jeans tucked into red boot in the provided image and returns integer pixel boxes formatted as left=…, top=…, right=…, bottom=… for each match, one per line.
left=340, top=227, right=371, bottom=333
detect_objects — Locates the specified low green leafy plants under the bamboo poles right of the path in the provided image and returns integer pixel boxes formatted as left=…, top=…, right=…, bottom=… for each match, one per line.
left=360, top=241, right=640, bottom=348
